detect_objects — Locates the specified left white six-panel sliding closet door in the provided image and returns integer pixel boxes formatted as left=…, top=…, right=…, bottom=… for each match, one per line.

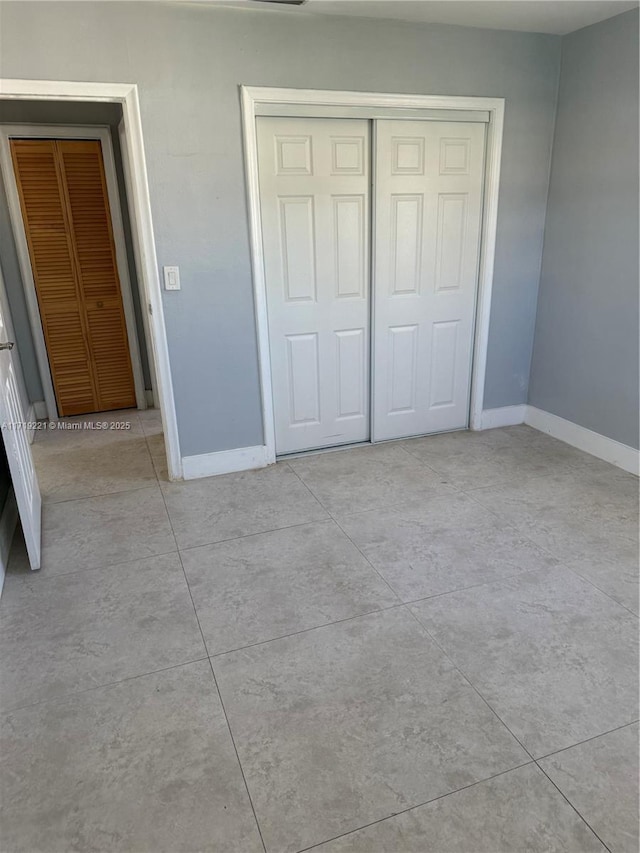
left=256, top=117, right=369, bottom=460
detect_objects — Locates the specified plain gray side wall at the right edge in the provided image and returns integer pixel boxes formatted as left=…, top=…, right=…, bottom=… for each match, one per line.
left=529, top=10, right=639, bottom=447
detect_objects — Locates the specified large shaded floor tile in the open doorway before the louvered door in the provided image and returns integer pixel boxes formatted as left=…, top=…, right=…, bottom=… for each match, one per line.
left=33, top=436, right=156, bottom=501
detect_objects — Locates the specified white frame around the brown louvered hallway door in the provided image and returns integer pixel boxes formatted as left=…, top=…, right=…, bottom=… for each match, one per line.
left=0, top=124, right=147, bottom=420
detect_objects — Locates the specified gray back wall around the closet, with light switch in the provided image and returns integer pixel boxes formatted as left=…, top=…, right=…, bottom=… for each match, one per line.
left=0, top=2, right=560, bottom=455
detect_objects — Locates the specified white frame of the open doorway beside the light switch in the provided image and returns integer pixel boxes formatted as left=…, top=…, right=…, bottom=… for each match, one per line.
left=0, top=78, right=182, bottom=480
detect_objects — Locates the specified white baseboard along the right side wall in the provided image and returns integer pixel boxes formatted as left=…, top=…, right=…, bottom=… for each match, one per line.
left=524, top=406, right=640, bottom=476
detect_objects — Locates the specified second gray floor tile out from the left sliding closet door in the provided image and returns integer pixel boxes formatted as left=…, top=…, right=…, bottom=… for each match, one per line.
left=340, top=494, right=556, bottom=601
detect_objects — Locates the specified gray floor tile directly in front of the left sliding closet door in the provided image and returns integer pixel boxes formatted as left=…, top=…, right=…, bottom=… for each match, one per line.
left=290, top=443, right=451, bottom=515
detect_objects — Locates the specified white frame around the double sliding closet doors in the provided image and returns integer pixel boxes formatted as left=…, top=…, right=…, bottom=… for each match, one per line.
left=240, top=86, right=505, bottom=464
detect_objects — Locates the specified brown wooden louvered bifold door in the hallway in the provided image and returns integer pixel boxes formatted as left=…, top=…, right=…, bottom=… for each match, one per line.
left=11, top=139, right=136, bottom=415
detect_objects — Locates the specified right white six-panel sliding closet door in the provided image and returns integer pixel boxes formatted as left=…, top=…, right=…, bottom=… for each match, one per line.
left=373, top=121, right=485, bottom=441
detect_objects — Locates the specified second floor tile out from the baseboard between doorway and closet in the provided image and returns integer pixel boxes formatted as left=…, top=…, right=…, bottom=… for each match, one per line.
left=182, top=521, right=398, bottom=654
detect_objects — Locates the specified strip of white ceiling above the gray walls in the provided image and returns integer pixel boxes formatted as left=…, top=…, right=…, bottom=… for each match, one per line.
left=209, top=0, right=638, bottom=35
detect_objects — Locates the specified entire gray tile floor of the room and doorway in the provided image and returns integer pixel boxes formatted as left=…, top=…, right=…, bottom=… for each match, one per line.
left=0, top=411, right=638, bottom=853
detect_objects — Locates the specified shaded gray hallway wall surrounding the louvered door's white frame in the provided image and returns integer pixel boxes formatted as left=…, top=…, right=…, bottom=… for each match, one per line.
left=0, top=98, right=151, bottom=412
